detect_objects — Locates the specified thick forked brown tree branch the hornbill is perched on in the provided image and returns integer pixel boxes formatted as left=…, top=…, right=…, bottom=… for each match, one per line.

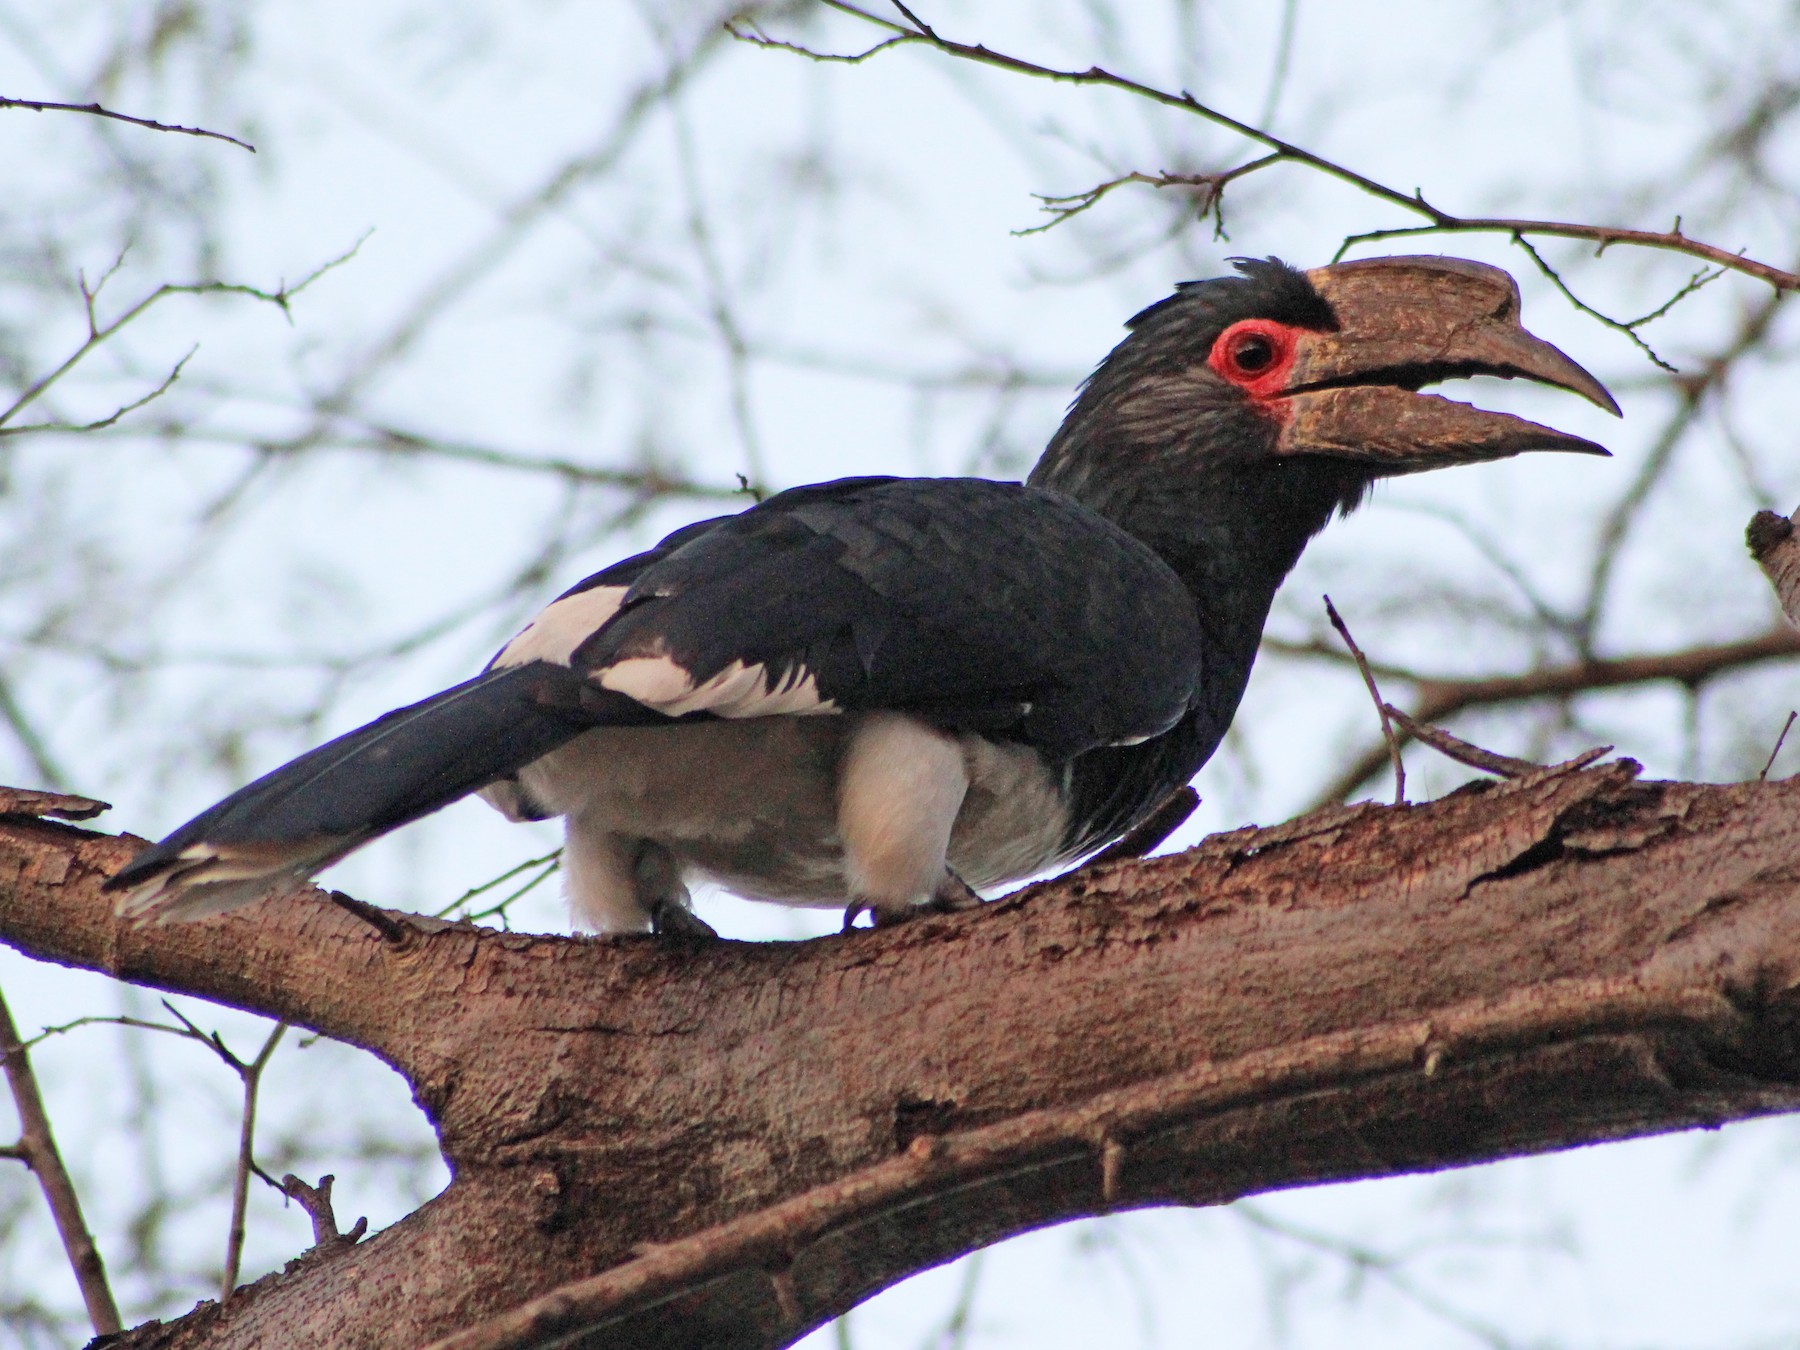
left=0, top=761, right=1800, bottom=1350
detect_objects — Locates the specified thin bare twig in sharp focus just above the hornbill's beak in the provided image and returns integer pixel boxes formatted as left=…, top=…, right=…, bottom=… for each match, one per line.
left=795, top=0, right=1800, bottom=292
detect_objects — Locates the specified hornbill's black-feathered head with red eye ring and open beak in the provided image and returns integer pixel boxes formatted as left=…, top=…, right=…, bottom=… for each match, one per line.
left=1031, top=257, right=1618, bottom=554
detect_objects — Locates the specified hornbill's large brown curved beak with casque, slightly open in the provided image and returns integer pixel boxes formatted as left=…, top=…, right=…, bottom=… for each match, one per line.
left=1276, top=257, right=1618, bottom=475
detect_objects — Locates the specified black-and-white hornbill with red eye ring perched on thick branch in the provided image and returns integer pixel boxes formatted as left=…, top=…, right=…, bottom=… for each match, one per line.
left=108, top=257, right=1618, bottom=931
